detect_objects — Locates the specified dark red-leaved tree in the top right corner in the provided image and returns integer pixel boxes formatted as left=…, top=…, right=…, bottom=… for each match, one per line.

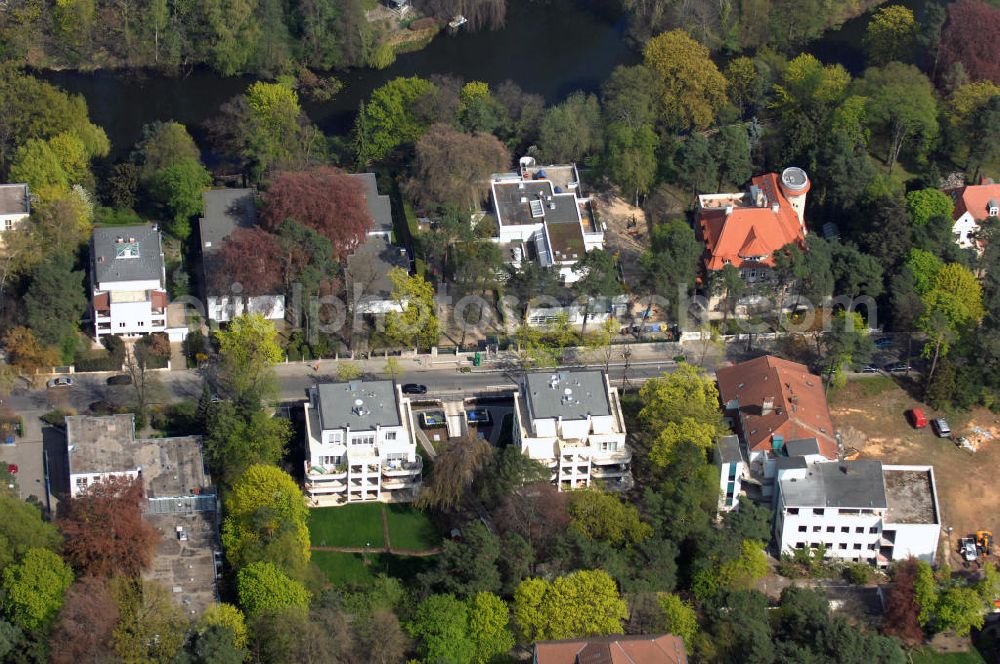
left=940, top=0, right=1000, bottom=84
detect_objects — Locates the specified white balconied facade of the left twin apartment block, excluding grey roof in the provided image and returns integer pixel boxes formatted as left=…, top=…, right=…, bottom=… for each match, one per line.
left=305, top=381, right=423, bottom=507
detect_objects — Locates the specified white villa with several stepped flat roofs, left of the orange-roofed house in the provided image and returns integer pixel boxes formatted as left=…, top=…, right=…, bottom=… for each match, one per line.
left=490, top=157, right=604, bottom=283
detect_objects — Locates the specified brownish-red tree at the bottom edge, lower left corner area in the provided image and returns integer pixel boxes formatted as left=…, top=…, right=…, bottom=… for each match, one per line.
left=49, top=576, right=118, bottom=664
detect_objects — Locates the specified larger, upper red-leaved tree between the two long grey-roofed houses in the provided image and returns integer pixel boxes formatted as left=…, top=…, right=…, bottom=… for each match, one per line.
left=262, top=166, right=372, bottom=262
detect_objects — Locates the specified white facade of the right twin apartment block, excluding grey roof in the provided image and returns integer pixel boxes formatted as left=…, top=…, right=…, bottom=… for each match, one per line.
left=514, top=372, right=633, bottom=491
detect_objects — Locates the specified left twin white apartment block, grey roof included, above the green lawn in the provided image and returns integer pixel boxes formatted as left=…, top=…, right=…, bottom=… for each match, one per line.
left=305, top=380, right=423, bottom=507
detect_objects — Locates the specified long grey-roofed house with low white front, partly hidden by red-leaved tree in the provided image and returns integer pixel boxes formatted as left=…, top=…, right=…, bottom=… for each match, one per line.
left=198, top=189, right=285, bottom=323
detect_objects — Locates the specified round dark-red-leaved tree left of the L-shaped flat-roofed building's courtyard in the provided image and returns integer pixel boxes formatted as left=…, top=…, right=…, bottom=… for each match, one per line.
left=56, top=477, right=160, bottom=579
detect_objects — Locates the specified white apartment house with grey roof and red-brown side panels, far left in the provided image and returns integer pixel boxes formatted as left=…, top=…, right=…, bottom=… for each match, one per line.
left=90, top=226, right=167, bottom=341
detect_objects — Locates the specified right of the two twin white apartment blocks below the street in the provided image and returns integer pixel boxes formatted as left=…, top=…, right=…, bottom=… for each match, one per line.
left=514, top=371, right=633, bottom=491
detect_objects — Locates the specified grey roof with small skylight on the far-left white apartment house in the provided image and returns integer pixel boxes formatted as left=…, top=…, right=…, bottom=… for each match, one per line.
left=90, top=225, right=163, bottom=287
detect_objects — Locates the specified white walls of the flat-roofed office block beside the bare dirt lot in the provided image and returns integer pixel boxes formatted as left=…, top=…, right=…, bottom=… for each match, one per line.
left=774, top=461, right=941, bottom=567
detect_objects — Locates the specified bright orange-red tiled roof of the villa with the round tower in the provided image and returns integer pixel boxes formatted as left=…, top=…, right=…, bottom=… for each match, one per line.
left=698, top=173, right=805, bottom=270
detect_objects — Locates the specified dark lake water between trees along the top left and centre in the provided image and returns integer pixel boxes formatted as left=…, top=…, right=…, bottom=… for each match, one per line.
left=41, top=0, right=640, bottom=156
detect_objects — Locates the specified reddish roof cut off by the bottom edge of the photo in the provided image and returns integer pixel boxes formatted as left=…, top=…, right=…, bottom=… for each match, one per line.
left=535, top=634, right=687, bottom=664
